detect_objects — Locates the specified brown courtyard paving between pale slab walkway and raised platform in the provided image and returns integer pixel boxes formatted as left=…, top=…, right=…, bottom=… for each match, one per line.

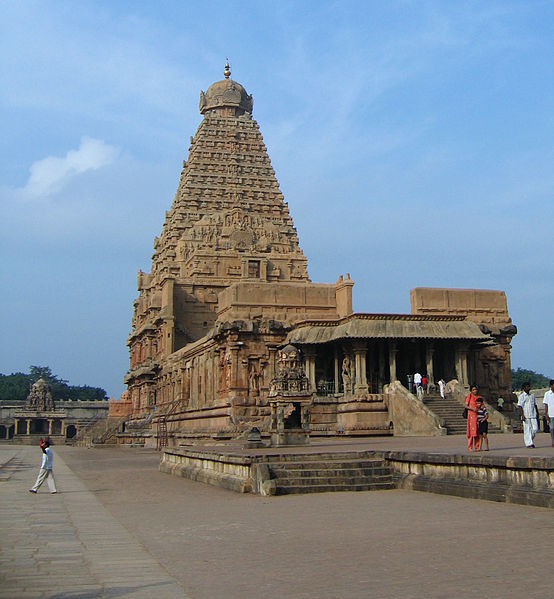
left=59, top=436, right=554, bottom=599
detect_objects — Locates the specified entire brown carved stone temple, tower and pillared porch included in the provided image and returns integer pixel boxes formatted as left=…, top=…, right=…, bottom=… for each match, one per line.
left=119, top=68, right=515, bottom=444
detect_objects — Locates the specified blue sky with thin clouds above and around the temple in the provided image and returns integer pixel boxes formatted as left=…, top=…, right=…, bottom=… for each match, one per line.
left=0, top=0, right=554, bottom=396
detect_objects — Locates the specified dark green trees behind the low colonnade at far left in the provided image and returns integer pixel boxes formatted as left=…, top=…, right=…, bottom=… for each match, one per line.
left=0, top=366, right=108, bottom=401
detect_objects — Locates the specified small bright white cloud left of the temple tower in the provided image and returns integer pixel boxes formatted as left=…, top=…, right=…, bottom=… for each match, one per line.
left=21, top=137, right=119, bottom=199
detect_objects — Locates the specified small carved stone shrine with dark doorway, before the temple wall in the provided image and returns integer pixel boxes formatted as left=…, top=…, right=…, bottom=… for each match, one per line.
left=268, top=344, right=314, bottom=447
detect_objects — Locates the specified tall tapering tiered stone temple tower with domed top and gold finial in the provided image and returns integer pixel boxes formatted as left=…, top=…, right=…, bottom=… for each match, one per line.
left=126, top=63, right=324, bottom=418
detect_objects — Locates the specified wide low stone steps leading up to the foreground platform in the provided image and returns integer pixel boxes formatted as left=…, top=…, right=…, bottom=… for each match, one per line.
left=267, top=454, right=397, bottom=495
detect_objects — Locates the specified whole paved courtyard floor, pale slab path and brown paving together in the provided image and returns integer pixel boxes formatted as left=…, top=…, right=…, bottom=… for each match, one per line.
left=0, top=435, right=554, bottom=599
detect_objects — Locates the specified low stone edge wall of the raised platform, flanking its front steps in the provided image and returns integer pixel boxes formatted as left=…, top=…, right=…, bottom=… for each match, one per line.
left=160, top=448, right=554, bottom=508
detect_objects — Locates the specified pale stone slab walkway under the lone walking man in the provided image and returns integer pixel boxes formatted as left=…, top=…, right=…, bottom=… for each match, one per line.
left=0, top=446, right=187, bottom=599
